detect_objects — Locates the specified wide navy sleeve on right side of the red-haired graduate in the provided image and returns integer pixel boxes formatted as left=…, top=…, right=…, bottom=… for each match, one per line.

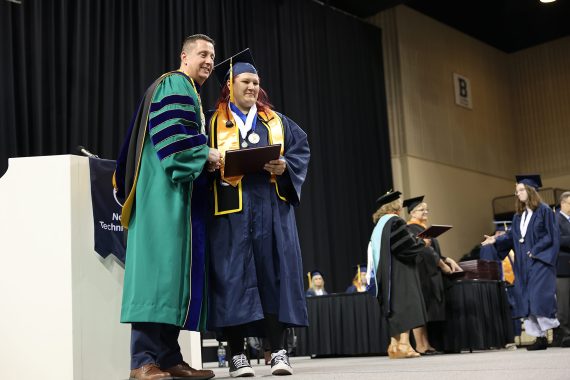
left=277, top=115, right=311, bottom=206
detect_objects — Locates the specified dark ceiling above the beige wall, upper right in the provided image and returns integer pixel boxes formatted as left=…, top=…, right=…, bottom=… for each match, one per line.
left=325, top=0, right=570, bottom=53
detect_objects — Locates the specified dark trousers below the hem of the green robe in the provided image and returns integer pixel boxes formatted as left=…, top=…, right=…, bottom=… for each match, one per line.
left=131, top=322, right=182, bottom=369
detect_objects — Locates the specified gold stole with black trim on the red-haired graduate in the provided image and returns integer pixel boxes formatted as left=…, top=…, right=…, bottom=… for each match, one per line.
left=210, top=103, right=287, bottom=215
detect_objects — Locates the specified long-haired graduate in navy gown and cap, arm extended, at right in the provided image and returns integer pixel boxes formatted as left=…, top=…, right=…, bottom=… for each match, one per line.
left=482, top=175, right=560, bottom=350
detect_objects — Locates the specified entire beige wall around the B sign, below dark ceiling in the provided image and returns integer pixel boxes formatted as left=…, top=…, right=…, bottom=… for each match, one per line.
left=369, top=6, right=570, bottom=258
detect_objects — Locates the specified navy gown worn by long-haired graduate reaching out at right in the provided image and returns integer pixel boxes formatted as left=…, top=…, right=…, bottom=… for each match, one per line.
left=496, top=203, right=560, bottom=318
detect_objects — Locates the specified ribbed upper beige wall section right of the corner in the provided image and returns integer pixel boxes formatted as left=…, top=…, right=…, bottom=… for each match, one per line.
left=509, top=37, right=570, bottom=176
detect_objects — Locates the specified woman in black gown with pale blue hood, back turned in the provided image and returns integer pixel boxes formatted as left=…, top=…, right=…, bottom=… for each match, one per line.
left=366, top=191, right=427, bottom=359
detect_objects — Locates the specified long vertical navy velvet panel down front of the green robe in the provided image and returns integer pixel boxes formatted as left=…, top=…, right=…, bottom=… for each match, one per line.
left=184, top=173, right=208, bottom=331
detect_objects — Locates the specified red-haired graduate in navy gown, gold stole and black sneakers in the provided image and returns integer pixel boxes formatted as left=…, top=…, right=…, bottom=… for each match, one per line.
left=207, top=49, right=310, bottom=377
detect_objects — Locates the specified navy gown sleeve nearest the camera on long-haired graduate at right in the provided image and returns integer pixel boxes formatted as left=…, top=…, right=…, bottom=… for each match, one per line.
left=530, top=205, right=560, bottom=265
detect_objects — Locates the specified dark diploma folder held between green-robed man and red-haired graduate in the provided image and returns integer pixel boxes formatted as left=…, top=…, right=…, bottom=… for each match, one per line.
left=224, top=144, right=281, bottom=177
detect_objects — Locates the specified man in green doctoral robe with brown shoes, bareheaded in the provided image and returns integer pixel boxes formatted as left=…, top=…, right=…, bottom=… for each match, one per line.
left=114, top=35, right=220, bottom=380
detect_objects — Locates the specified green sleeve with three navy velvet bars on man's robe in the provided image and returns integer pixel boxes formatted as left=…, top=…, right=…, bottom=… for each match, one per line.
left=148, top=75, right=209, bottom=183
